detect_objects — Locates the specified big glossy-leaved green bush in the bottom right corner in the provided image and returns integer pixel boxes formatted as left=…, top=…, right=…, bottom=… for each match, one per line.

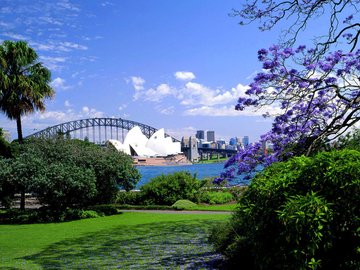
left=210, top=150, right=360, bottom=269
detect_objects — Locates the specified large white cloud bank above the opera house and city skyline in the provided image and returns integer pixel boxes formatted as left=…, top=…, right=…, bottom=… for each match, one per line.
left=128, top=73, right=281, bottom=116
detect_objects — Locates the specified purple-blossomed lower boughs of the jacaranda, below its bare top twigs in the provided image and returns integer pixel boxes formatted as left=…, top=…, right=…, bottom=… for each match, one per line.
left=216, top=46, right=360, bottom=185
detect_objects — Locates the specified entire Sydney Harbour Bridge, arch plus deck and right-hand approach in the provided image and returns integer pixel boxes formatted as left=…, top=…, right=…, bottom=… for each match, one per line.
left=27, top=118, right=236, bottom=156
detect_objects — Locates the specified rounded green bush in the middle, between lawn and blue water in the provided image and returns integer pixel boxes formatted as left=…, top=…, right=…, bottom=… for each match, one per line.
left=140, top=172, right=201, bottom=205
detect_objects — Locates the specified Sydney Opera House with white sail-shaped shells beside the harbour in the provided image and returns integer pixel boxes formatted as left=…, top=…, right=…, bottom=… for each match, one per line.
left=108, top=126, right=188, bottom=165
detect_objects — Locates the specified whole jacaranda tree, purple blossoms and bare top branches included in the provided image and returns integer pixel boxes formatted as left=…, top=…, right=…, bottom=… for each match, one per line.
left=217, top=0, right=360, bottom=182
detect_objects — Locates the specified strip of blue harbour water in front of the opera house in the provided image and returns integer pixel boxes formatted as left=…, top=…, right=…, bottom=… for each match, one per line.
left=136, top=163, right=248, bottom=189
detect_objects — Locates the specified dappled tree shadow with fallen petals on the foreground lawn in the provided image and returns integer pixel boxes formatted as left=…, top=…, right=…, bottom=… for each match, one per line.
left=24, top=220, right=226, bottom=269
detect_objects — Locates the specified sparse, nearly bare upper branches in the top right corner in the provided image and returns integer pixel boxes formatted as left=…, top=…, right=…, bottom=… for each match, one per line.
left=232, top=0, right=360, bottom=54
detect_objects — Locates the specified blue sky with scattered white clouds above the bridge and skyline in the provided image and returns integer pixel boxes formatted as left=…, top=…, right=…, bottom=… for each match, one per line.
left=0, top=0, right=306, bottom=141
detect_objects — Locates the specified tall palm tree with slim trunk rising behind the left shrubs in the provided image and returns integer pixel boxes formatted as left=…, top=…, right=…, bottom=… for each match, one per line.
left=0, top=40, right=55, bottom=209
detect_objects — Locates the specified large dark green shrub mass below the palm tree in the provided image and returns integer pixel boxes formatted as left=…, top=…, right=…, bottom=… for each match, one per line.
left=0, top=137, right=140, bottom=208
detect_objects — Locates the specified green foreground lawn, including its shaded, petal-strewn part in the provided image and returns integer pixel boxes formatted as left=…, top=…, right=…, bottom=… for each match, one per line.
left=0, top=213, right=230, bottom=270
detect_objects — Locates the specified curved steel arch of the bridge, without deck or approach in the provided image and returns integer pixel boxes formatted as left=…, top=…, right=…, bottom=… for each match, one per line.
left=26, top=118, right=179, bottom=142
